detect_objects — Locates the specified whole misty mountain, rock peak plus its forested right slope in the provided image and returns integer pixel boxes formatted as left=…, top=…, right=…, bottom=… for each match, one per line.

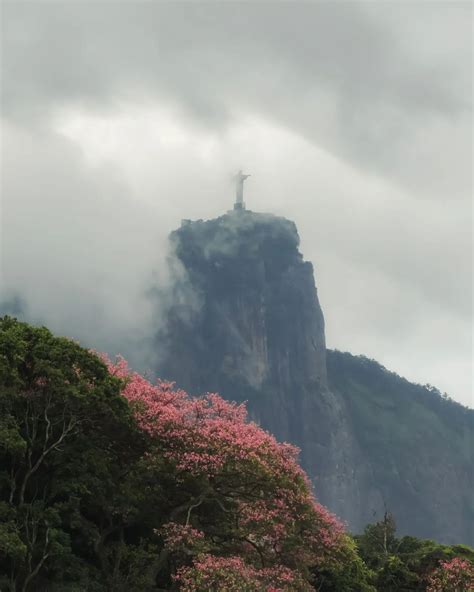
left=156, top=211, right=474, bottom=544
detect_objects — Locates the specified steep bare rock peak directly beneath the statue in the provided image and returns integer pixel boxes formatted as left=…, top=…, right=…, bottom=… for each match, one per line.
left=158, top=211, right=472, bottom=541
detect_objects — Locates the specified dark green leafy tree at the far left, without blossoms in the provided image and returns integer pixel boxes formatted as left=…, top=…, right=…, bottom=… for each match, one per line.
left=0, top=317, right=143, bottom=592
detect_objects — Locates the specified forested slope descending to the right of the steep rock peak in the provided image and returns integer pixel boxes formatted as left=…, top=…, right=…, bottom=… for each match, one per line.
left=327, top=350, right=474, bottom=545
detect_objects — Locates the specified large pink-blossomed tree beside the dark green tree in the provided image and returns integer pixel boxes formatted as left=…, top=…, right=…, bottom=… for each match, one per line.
left=109, top=359, right=349, bottom=592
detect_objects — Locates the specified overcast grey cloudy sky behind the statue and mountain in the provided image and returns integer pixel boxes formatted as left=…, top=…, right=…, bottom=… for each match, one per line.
left=1, top=0, right=472, bottom=405
